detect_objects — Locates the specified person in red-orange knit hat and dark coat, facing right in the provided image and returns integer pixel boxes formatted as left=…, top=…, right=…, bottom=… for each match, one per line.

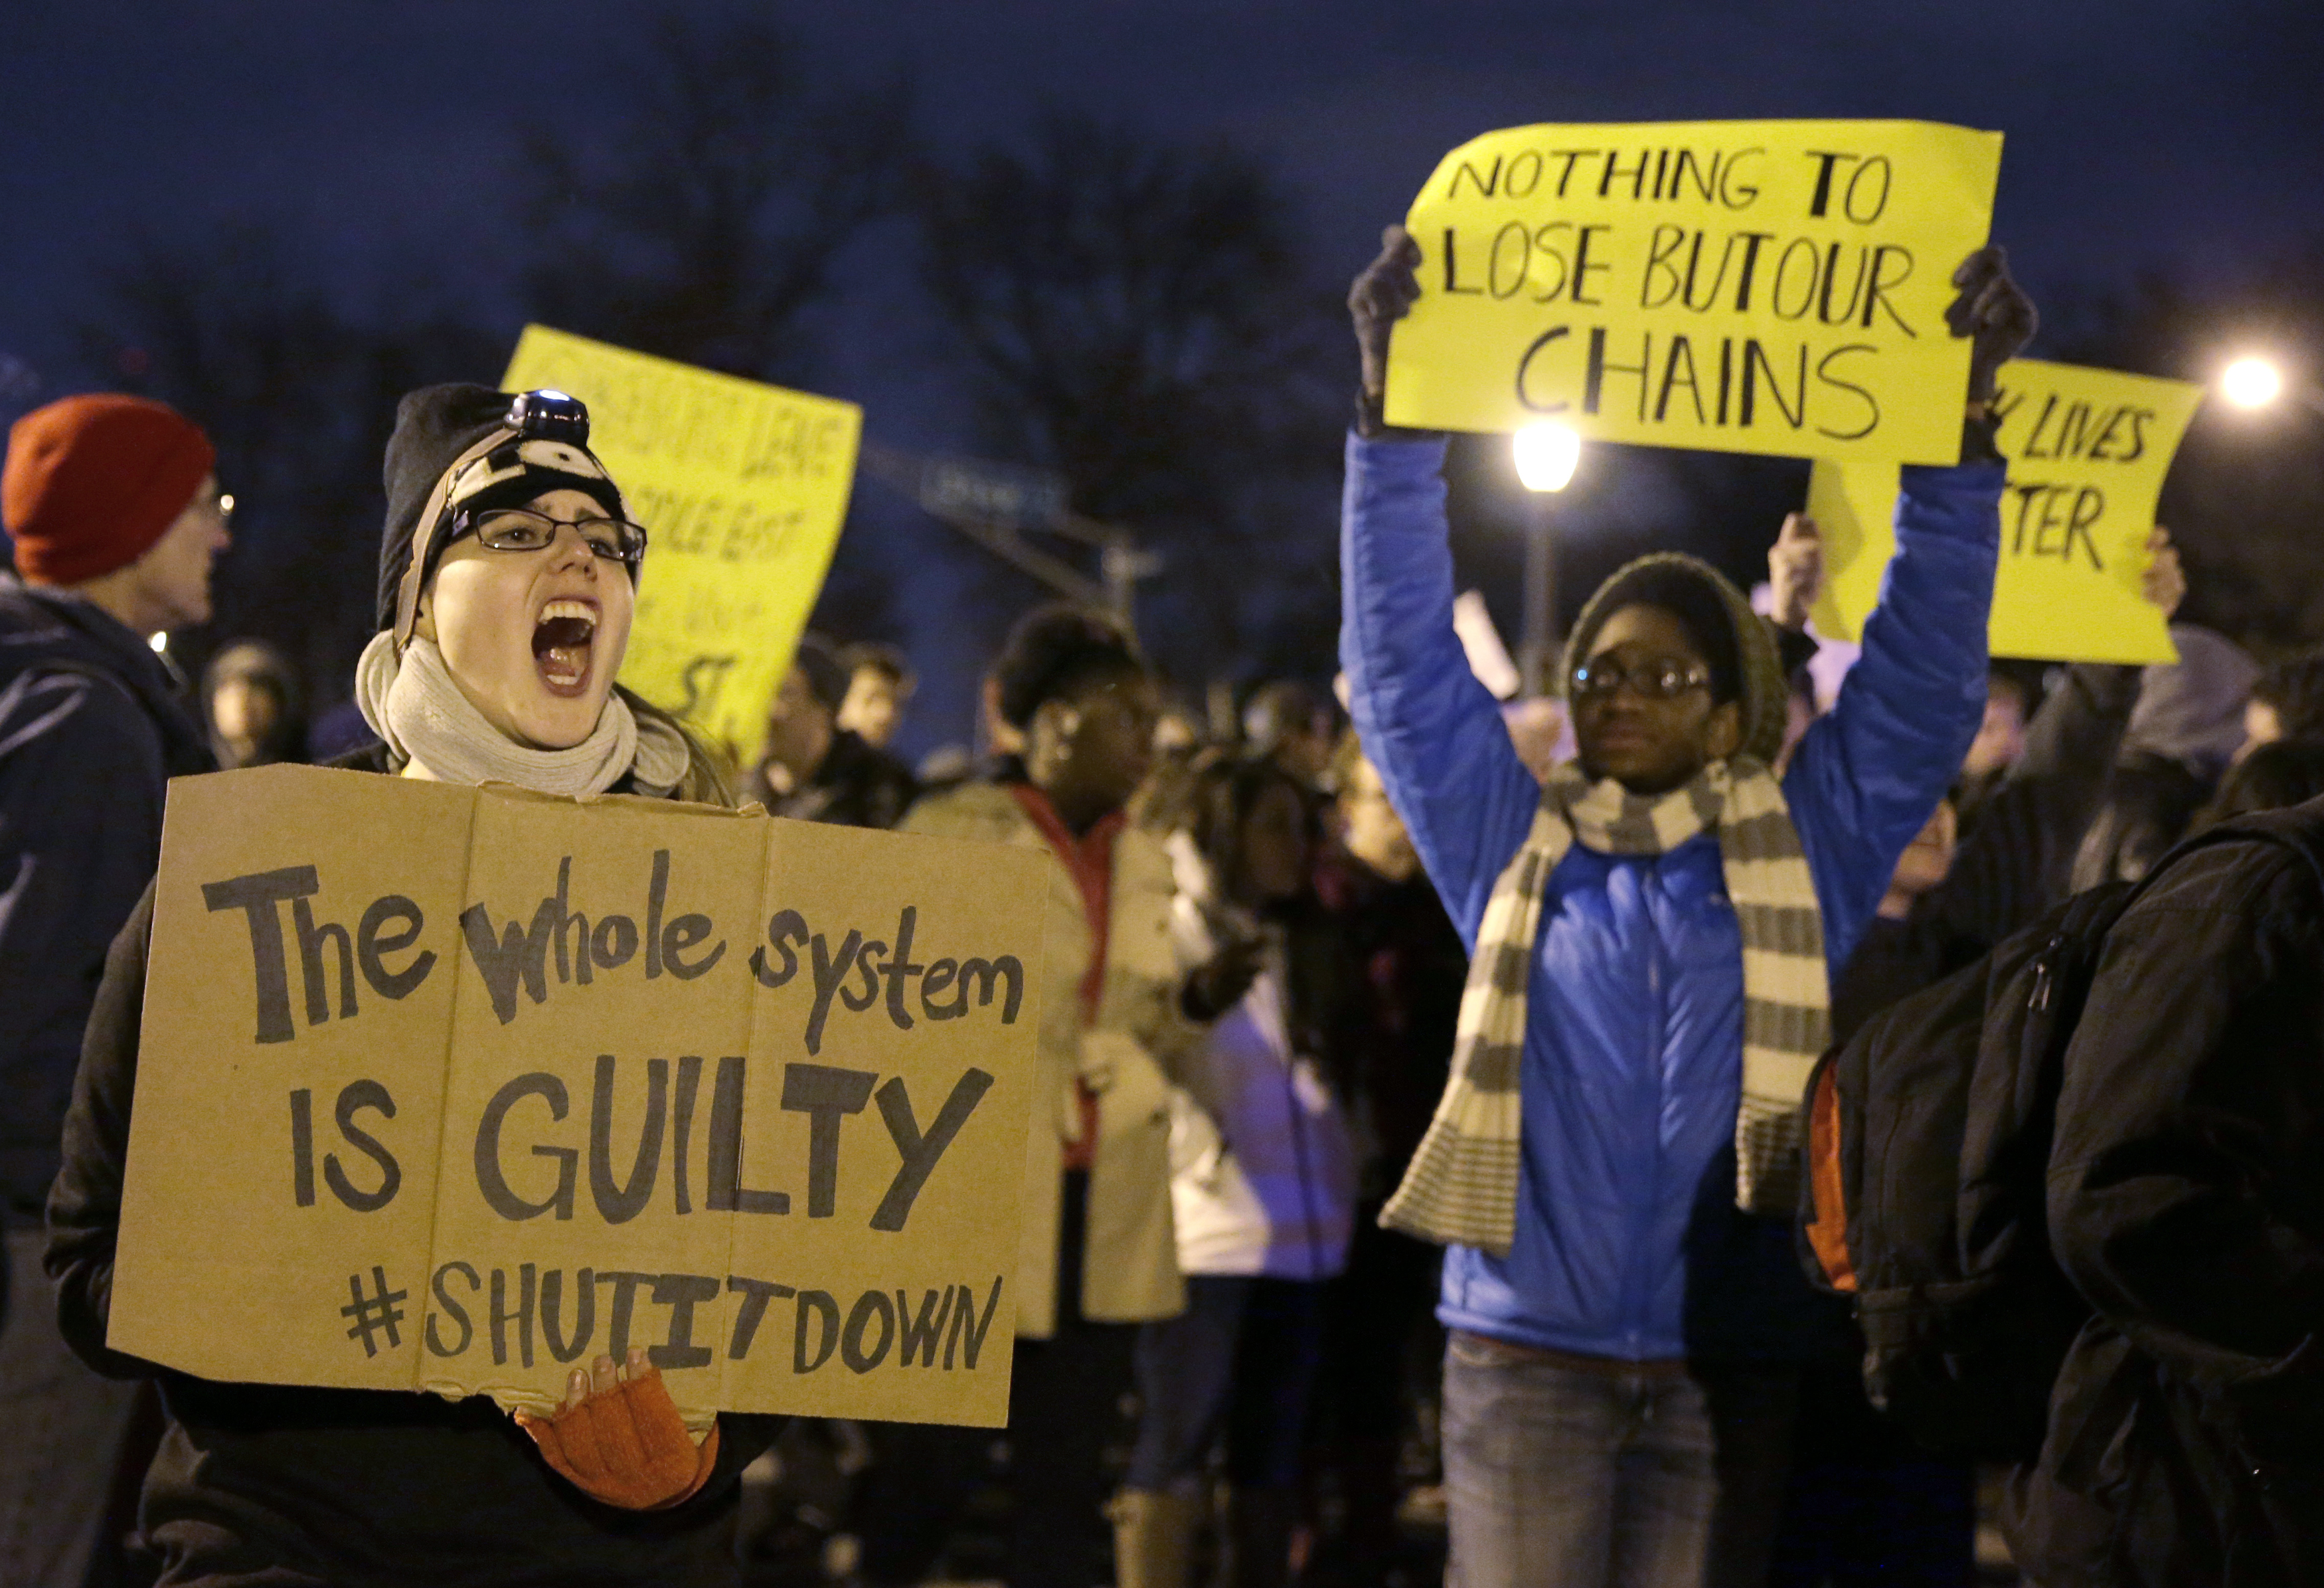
left=0, top=395, right=228, bottom=1583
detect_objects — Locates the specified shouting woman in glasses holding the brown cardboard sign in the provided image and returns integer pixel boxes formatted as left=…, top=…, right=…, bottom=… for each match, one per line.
left=46, top=386, right=772, bottom=1588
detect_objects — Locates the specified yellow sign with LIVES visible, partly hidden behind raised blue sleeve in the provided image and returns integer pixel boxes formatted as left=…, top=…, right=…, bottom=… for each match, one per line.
left=1808, top=358, right=2203, bottom=663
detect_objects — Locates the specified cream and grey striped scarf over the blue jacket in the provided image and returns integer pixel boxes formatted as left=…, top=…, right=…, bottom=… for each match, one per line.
left=1380, top=756, right=1831, bottom=1255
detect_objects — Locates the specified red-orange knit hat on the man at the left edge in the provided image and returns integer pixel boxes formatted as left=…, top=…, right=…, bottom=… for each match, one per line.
left=0, top=393, right=218, bottom=584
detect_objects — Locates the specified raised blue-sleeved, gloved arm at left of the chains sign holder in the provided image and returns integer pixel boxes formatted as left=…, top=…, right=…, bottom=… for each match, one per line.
left=1339, top=226, right=1541, bottom=944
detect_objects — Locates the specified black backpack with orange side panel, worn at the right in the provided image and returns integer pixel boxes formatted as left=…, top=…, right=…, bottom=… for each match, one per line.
left=1799, top=802, right=2324, bottom=1462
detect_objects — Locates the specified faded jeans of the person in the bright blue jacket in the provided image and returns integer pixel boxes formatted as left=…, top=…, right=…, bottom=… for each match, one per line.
left=1444, top=1330, right=1720, bottom=1588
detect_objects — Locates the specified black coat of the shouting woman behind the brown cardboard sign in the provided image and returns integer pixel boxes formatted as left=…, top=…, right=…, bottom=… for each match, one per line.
left=49, top=744, right=779, bottom=1588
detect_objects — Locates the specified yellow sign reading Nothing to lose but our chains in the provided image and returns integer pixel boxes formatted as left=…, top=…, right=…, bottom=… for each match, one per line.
left=1385, top=121, right=2001, bottom=463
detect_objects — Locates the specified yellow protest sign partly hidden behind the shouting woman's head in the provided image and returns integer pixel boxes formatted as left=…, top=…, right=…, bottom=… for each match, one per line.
left=502, top=325, right=863, bottom=760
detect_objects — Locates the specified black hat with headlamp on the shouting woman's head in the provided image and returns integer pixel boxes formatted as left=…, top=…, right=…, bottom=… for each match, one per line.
left=376, top=384, right=627, bottom=628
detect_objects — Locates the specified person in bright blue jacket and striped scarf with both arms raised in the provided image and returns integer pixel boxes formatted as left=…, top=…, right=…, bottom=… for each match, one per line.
left=1341, top=228, right=2034, bottom=1588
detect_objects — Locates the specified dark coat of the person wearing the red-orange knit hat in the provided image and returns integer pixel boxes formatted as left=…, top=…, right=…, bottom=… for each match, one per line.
left=0, top=574, right=214, bottom=1218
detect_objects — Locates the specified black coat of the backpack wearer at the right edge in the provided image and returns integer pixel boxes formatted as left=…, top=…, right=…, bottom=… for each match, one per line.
left=2011, top=818, right=2324, bottom=1588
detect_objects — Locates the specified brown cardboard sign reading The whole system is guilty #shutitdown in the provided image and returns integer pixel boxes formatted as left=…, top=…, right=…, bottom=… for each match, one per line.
left=107, top=767, right=1046, bottom=1427
